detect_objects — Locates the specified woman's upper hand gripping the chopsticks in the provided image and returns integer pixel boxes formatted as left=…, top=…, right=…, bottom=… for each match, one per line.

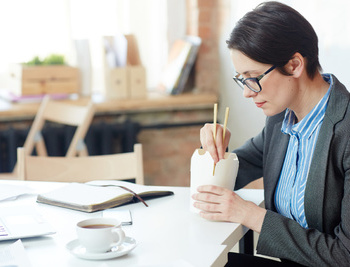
left=200, top=123, right=231, bottom=163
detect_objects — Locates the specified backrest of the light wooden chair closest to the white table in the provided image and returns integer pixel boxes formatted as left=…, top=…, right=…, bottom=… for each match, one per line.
left=17, top=144, right=144, bottom=184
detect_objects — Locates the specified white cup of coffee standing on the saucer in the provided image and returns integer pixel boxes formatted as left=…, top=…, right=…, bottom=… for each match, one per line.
left=76, top=218, right=125, bottom=253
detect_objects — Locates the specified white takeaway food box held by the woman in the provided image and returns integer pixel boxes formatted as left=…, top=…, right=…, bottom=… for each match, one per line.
left=190, top=149, right=239, bottom=213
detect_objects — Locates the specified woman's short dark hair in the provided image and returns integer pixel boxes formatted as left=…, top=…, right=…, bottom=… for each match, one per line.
left=226, top=1, right=321, bottom=79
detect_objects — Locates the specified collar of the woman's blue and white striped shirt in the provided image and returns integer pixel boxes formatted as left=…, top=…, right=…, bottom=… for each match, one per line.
left=281, top=74, right=333, bottom=138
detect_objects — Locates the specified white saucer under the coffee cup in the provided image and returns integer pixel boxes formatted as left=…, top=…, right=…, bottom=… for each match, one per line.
left=66, top=236, right=136, bottom=260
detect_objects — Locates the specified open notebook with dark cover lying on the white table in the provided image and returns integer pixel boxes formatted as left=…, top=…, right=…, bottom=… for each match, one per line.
left=37, top=180, right=174, bottom=212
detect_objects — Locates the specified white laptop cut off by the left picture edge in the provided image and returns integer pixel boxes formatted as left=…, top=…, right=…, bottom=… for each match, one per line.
left=0, top=206, right=55, bottom=241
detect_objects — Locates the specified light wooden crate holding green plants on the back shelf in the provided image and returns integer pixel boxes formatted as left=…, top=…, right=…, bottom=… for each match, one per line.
left=9, top=64, right=80, bottom=96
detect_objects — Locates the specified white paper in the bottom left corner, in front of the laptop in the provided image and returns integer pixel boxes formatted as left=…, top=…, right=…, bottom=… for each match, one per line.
left=0, top=240, right=31, bottom=267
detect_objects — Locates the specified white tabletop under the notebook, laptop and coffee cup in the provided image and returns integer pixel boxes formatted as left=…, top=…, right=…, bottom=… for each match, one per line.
left=0, top=180, right=263, bottom=267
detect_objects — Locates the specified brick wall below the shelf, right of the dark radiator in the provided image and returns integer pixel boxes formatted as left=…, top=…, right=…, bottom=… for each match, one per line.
left=138, top=126, right=201, bottom=186
